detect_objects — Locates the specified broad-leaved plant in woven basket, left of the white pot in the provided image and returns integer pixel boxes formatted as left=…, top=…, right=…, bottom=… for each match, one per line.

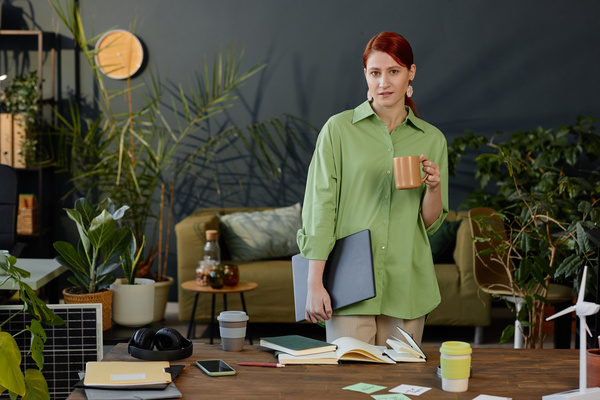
left=54, top=197, right=133, bottom=330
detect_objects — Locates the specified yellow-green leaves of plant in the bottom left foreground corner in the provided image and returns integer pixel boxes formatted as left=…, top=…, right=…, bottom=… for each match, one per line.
left=0, top=252, right=64, bottom=400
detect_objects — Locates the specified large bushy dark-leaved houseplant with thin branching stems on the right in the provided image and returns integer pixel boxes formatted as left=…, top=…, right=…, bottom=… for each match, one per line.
left=448, top=117, right=600, bottom=348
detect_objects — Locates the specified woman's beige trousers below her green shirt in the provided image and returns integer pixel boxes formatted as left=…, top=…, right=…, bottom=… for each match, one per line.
left=326, top=315, right=425, bottom=346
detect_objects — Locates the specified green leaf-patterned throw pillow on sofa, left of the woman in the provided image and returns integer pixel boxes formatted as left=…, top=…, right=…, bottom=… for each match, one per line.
left=218, top=203, right=302, bottom=261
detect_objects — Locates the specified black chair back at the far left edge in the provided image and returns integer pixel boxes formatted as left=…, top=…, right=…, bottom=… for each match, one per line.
left=0, top=165, right=25, bottom=257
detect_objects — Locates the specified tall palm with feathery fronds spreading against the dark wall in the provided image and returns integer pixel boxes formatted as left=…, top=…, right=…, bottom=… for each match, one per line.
left=51, top=0, right=314, bottom=280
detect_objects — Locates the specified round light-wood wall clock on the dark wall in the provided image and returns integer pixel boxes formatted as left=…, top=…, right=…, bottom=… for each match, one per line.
left=96, top=29, right=144, bottom=79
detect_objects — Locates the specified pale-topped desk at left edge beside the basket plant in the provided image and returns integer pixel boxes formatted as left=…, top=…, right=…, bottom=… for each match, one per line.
left=0, top=258, right=67, bottom=304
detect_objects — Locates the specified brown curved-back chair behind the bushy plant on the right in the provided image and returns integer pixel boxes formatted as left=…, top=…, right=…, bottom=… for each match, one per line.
left=469, top=207, right=573, bottom=349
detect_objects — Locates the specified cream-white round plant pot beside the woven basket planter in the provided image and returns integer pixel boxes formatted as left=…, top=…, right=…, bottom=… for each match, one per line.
left=110, top=278, right=154, bottom=328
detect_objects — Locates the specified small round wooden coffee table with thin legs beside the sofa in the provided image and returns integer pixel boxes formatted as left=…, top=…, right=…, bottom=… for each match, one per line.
left=181, top=279, right=258, bottom=344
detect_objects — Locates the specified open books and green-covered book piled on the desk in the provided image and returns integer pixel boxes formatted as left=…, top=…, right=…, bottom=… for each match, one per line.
left=260, top=328, right=427, bottom=365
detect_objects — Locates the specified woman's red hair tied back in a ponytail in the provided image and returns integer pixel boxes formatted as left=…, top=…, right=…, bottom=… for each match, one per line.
left=363, top=32, right=418, bottom=116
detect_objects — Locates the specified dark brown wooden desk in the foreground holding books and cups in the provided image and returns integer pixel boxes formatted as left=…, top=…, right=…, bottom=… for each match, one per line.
left=68, top=343, right=579, bottom=400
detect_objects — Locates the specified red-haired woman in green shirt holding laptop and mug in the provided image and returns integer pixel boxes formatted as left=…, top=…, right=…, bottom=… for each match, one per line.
left=297, top=32, right=448, bottom=345
